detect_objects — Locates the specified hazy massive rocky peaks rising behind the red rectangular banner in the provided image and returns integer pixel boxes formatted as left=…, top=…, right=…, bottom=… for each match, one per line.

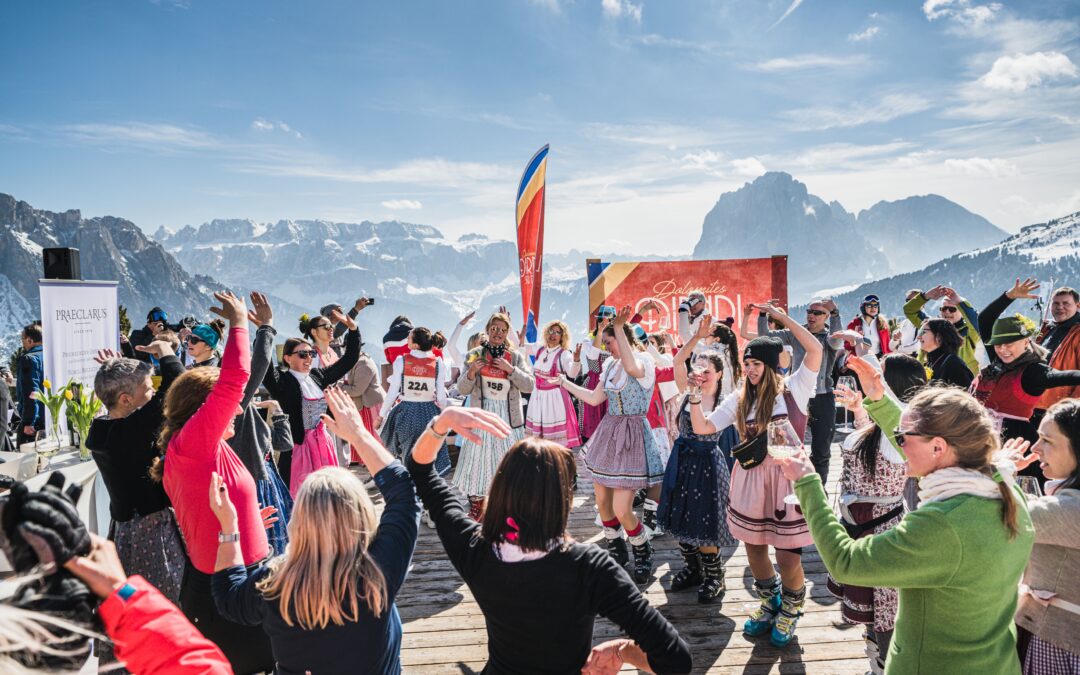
left=693, top=172, right=1008, bottom=301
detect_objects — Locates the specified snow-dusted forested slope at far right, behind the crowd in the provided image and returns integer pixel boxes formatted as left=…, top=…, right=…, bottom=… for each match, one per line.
left=816, top=213, right=1080, bottom=319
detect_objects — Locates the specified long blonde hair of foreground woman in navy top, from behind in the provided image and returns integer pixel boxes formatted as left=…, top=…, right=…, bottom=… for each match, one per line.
left=257, top=467, right=389, bottom=631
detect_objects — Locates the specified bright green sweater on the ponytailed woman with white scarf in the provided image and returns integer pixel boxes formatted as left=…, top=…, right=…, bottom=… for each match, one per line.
left=795, top=399, right=1035, bottom=675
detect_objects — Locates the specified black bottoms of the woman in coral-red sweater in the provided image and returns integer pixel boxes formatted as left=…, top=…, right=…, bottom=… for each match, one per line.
left=180, top=563, right=274, bottom=675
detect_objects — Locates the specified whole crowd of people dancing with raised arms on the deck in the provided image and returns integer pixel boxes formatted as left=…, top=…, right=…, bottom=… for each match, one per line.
left=0, top=280, right=1080, bottom=675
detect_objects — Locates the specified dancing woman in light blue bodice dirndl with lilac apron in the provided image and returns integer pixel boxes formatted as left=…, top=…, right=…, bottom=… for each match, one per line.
left=556, top=306, right=663, bottom=583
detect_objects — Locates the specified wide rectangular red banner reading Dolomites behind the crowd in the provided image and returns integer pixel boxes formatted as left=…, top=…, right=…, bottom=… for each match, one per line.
left=585, top=256, right=787, bottom=337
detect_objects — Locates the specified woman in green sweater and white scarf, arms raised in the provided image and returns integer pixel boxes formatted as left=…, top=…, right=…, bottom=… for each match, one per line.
left=779, top=359, right=1034, bottom=675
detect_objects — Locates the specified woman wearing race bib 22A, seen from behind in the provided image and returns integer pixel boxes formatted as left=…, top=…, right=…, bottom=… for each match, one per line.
left=379, top=326, right=450, bottom=475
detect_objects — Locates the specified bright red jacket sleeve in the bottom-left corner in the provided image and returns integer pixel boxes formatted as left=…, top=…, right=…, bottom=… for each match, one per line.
left=97, top=576, right=232, bottom=675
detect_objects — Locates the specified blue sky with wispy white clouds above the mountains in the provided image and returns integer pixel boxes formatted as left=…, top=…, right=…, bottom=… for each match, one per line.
left=0, top=0, right=1080, bottom=254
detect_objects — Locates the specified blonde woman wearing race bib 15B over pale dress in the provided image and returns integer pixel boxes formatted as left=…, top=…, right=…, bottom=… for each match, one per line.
left=454, top=312, right=534, bottom=521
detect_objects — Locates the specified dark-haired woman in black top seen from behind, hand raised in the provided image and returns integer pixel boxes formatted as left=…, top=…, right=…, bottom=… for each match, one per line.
left=406, top=408, right=692, bottom=675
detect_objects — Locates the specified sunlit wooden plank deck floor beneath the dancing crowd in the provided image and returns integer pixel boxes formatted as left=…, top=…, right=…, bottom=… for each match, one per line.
left=365, top=448, right=868, bottom=675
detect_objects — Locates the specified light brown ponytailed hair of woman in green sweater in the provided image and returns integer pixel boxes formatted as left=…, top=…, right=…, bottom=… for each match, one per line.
left=907, top=387, right=1018, bottom=539
